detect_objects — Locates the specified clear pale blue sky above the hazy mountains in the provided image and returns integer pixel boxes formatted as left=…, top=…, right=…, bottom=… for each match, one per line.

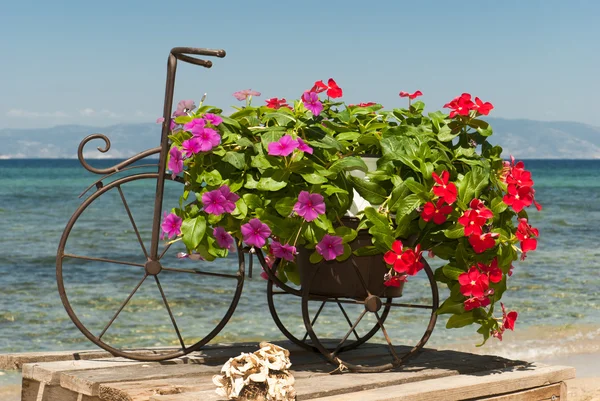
left=0, top=0, right=600, bottom=128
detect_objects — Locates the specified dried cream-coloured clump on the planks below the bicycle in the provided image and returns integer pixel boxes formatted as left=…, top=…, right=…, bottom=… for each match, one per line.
left=213, top=342, right=296, bottom=401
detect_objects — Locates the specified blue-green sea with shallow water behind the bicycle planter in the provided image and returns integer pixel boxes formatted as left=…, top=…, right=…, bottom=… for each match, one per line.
left=0, top=159, right=600, bottom=386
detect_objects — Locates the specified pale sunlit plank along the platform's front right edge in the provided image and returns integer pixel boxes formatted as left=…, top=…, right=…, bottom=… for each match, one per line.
left=304, top=364, right=575, bottom=401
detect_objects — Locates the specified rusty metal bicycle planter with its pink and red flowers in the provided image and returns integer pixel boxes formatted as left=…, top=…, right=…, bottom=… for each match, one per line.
left=56, top=48, right=537, bottom=372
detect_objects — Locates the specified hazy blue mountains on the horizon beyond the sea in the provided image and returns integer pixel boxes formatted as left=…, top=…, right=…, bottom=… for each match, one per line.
left=0, top=118, right=600, bottom=159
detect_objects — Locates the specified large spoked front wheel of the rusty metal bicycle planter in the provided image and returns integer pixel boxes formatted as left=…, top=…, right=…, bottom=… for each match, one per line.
left=56, top=173, right=244, bottom=361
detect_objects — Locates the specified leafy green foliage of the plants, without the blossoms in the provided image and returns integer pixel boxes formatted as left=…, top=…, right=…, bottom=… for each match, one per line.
left=164, top=89, right=540, bottom=342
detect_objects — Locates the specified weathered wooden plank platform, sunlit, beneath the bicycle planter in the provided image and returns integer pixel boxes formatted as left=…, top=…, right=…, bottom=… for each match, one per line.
left=0, top=342, right=575, bottom=401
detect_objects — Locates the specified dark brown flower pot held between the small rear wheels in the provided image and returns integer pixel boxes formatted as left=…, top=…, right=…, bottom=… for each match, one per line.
left=296, top=218, right=404, bottom=299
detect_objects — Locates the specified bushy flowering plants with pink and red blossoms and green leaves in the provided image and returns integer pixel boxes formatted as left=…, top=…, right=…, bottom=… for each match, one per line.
left=162, top=79, right=541, bottom=342
